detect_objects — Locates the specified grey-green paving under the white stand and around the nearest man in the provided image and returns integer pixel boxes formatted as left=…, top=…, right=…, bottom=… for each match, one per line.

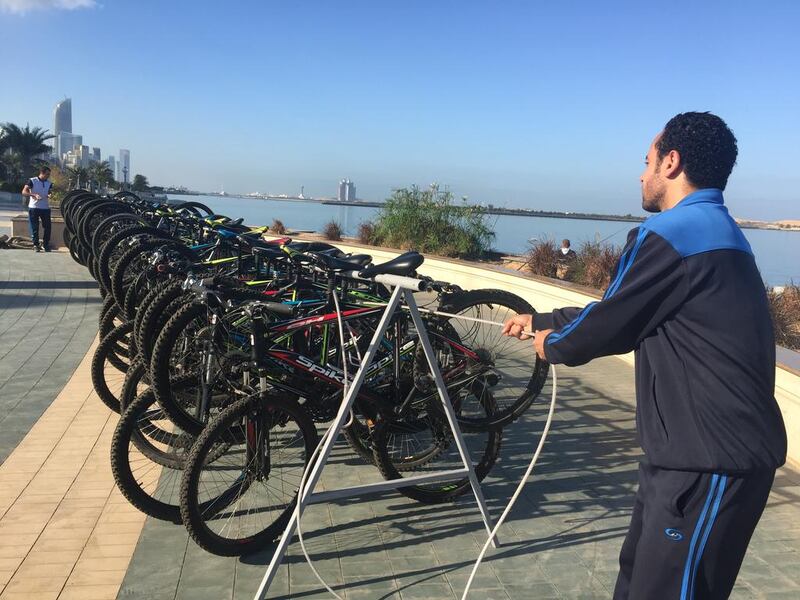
left=111, top=359, right=800, bottom=600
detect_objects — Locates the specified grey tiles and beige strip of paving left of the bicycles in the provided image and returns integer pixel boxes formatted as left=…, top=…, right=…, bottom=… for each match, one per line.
left=0, top=252, right=144, bottom=600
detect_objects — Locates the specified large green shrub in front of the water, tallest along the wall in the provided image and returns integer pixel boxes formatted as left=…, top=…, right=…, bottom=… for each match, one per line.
left=372, top=185, right=494, bottom=258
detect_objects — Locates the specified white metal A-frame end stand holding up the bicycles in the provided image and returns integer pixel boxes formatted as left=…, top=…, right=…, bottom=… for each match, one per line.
left=255, top=275, right=499, bottom=600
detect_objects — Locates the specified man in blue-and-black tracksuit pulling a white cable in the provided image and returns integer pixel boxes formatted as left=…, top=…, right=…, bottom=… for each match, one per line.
left=504, top=113, right=786, bottom=600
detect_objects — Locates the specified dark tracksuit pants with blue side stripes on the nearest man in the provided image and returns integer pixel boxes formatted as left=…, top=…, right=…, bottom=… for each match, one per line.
left=614, top=463, right=775, bottom=600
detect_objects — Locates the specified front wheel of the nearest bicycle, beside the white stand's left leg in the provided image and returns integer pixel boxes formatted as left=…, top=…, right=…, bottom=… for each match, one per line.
left=181, top=394, right=317, bottom=556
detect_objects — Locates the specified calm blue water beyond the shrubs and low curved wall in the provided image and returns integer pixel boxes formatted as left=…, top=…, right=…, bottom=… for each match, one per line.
left=170, top=196, right=800, bottom=285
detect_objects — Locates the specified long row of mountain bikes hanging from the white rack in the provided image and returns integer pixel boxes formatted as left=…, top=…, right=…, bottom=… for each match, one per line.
left=62, top=190, right=547, bottom=555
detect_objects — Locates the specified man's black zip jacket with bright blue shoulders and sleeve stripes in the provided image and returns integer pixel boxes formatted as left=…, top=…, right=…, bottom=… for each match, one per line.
left=534, top=189, right=786, bottom=473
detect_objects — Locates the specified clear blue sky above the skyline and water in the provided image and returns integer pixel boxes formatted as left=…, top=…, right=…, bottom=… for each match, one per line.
left=0, top=0, right=800, bottom=220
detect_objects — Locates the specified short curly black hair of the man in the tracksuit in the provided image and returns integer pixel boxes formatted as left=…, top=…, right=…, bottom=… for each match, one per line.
left=656, top=112, right=739, bottom=190
